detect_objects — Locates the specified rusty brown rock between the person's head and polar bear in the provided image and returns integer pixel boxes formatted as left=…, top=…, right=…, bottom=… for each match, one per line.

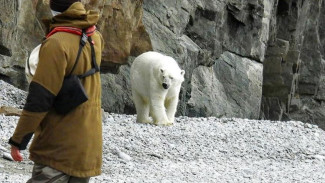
left=97, top=0, right=152, bottom=71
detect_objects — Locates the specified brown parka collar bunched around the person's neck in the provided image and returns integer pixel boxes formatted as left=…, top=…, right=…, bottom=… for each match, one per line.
left=50, top=2, right=99, bottom=30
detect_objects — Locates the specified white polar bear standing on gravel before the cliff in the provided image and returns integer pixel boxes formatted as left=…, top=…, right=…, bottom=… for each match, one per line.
left=130, top=51, right=185, bottom=125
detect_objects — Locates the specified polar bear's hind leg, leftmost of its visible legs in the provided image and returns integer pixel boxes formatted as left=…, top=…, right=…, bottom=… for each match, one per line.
left=132, top=90, right=152, bottom=123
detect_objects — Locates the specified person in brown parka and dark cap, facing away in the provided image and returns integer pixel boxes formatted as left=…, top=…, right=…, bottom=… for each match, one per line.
left=9, top=0, right=104, bottom=183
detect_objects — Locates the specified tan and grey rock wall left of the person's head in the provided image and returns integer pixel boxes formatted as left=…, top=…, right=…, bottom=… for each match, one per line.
left=0, top=0, right=44, bottom=89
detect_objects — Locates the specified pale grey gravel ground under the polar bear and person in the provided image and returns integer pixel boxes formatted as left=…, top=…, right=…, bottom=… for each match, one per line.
left=0, top=81, right=325, bottom=183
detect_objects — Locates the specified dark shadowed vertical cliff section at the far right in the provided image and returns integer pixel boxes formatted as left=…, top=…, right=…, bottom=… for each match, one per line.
left=262, top=0, right=325, bottom=129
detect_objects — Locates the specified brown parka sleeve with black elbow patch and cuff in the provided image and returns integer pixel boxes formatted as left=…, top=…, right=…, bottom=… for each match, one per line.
left=9, top=37, right=67, bottom=150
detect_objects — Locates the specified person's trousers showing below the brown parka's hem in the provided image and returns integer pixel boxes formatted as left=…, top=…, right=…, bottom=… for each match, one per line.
left=27, top=164, right=90, bottom=183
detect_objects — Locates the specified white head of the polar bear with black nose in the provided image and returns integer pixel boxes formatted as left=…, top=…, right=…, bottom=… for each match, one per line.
left=159, top=67, right=185, bottom=90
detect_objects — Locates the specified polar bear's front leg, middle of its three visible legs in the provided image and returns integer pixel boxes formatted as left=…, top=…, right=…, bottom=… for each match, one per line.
left=150, top=96, right=170, bottom=125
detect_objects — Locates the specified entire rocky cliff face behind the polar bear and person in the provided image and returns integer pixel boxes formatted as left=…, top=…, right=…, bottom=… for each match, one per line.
left=0, top=0, right=325, bottom=128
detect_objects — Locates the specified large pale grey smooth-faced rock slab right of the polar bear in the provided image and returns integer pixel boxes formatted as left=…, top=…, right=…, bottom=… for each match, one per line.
left=214, top=52, right=263, bottom=119
